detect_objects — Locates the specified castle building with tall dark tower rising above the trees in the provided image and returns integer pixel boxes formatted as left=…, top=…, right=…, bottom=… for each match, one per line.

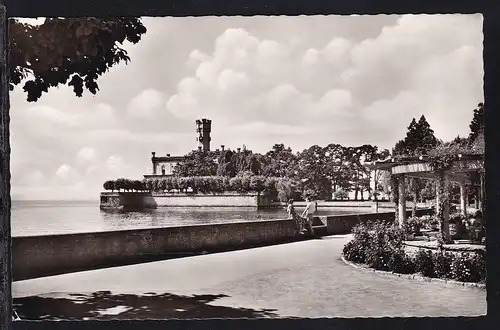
left=144, top=119, right=212, bottom=178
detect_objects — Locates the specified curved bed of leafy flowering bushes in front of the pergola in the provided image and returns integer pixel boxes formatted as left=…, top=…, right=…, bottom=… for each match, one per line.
left=343, top=222, right=486, bottom=283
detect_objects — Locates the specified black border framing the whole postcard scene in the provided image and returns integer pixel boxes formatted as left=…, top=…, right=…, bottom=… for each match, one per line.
left=0, top=0, right=500, bottom=330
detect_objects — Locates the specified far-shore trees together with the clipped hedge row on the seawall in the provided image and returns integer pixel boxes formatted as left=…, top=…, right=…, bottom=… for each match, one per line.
left=104, top=144, right=390, bottom=201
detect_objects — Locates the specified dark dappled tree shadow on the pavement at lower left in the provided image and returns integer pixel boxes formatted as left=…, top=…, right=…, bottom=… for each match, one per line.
left=13, top=291, right=278, bottom=320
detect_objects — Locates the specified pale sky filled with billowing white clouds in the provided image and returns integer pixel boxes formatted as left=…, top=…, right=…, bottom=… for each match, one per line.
left=11, top=15, right=483, bottom=199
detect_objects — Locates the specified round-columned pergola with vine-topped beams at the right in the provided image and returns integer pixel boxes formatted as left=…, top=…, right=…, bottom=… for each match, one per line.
left=367, top=154, right=484, bottom=242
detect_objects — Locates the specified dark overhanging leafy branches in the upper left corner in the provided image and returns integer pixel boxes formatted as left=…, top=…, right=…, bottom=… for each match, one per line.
left=9, top=18, right=146, bottom=102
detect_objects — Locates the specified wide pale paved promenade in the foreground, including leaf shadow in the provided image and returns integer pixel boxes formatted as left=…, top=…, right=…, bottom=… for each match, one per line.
left=12, top=235, right=486, bottom=319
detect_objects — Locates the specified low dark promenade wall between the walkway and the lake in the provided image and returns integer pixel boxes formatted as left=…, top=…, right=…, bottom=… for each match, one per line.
left=12, top=212, right=434, bottom=281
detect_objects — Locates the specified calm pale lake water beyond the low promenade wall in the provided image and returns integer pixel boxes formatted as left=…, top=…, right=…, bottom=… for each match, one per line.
left=11, top=201, right=370, bottom=236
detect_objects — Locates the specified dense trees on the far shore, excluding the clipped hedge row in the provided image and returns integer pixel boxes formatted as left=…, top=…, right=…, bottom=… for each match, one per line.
left=169, top=144, right=389, bottom=200
